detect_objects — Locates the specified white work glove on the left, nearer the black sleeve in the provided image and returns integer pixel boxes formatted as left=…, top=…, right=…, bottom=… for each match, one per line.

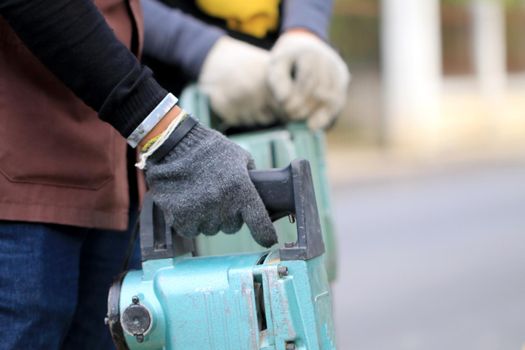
left=198, top=36, right=277, bottom=126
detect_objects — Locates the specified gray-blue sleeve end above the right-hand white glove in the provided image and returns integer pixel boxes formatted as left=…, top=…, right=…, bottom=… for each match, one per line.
left=281, top=0, right=333, bottom=41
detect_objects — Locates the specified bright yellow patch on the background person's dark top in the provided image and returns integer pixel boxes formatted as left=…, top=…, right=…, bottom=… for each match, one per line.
left=196, top=0, right=280, bottom=38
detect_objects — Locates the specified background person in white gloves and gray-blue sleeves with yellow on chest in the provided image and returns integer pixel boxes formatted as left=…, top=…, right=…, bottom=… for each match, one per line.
left=142, top=0, right=350, bottom=130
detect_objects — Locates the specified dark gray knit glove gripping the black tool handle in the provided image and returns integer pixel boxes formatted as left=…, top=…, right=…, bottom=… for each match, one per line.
left=141, top=124, right=277, bottom=247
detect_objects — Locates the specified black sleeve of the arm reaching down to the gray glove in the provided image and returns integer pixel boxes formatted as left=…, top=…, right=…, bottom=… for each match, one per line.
left=0, top=0, right=167, bottom=137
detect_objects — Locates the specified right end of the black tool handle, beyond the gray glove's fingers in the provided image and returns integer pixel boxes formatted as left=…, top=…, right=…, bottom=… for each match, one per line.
left=250, top=159, right=325, bottom=260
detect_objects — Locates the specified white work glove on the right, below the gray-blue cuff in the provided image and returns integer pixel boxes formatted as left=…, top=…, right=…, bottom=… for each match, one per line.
left=268, top=31, right=350, bottom=130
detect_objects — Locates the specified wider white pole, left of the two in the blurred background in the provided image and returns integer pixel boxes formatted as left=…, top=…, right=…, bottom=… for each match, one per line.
left=381, top=0, right=442, bottom=148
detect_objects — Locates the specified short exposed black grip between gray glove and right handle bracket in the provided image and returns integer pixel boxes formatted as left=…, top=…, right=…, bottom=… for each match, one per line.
left=250, top=166, right=295, bottom=221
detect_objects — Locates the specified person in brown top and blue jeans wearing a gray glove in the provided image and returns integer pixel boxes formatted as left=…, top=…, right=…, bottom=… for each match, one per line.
left=0, top=0, right=270, bottom=350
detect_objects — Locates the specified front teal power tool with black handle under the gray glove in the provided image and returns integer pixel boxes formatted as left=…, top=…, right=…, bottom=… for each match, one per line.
left=107, top=160, right=335, bottom=350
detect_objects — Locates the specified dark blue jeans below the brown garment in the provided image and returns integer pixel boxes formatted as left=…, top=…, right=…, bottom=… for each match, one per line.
left=0, top=215, right=140, bottom=350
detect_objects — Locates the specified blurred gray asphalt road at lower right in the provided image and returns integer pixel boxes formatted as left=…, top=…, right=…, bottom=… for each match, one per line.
left=333, top=162, right=525, bottom=350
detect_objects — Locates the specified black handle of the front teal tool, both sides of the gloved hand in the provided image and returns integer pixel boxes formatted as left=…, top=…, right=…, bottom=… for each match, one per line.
left=140, top=159, right=324, bottom=261
